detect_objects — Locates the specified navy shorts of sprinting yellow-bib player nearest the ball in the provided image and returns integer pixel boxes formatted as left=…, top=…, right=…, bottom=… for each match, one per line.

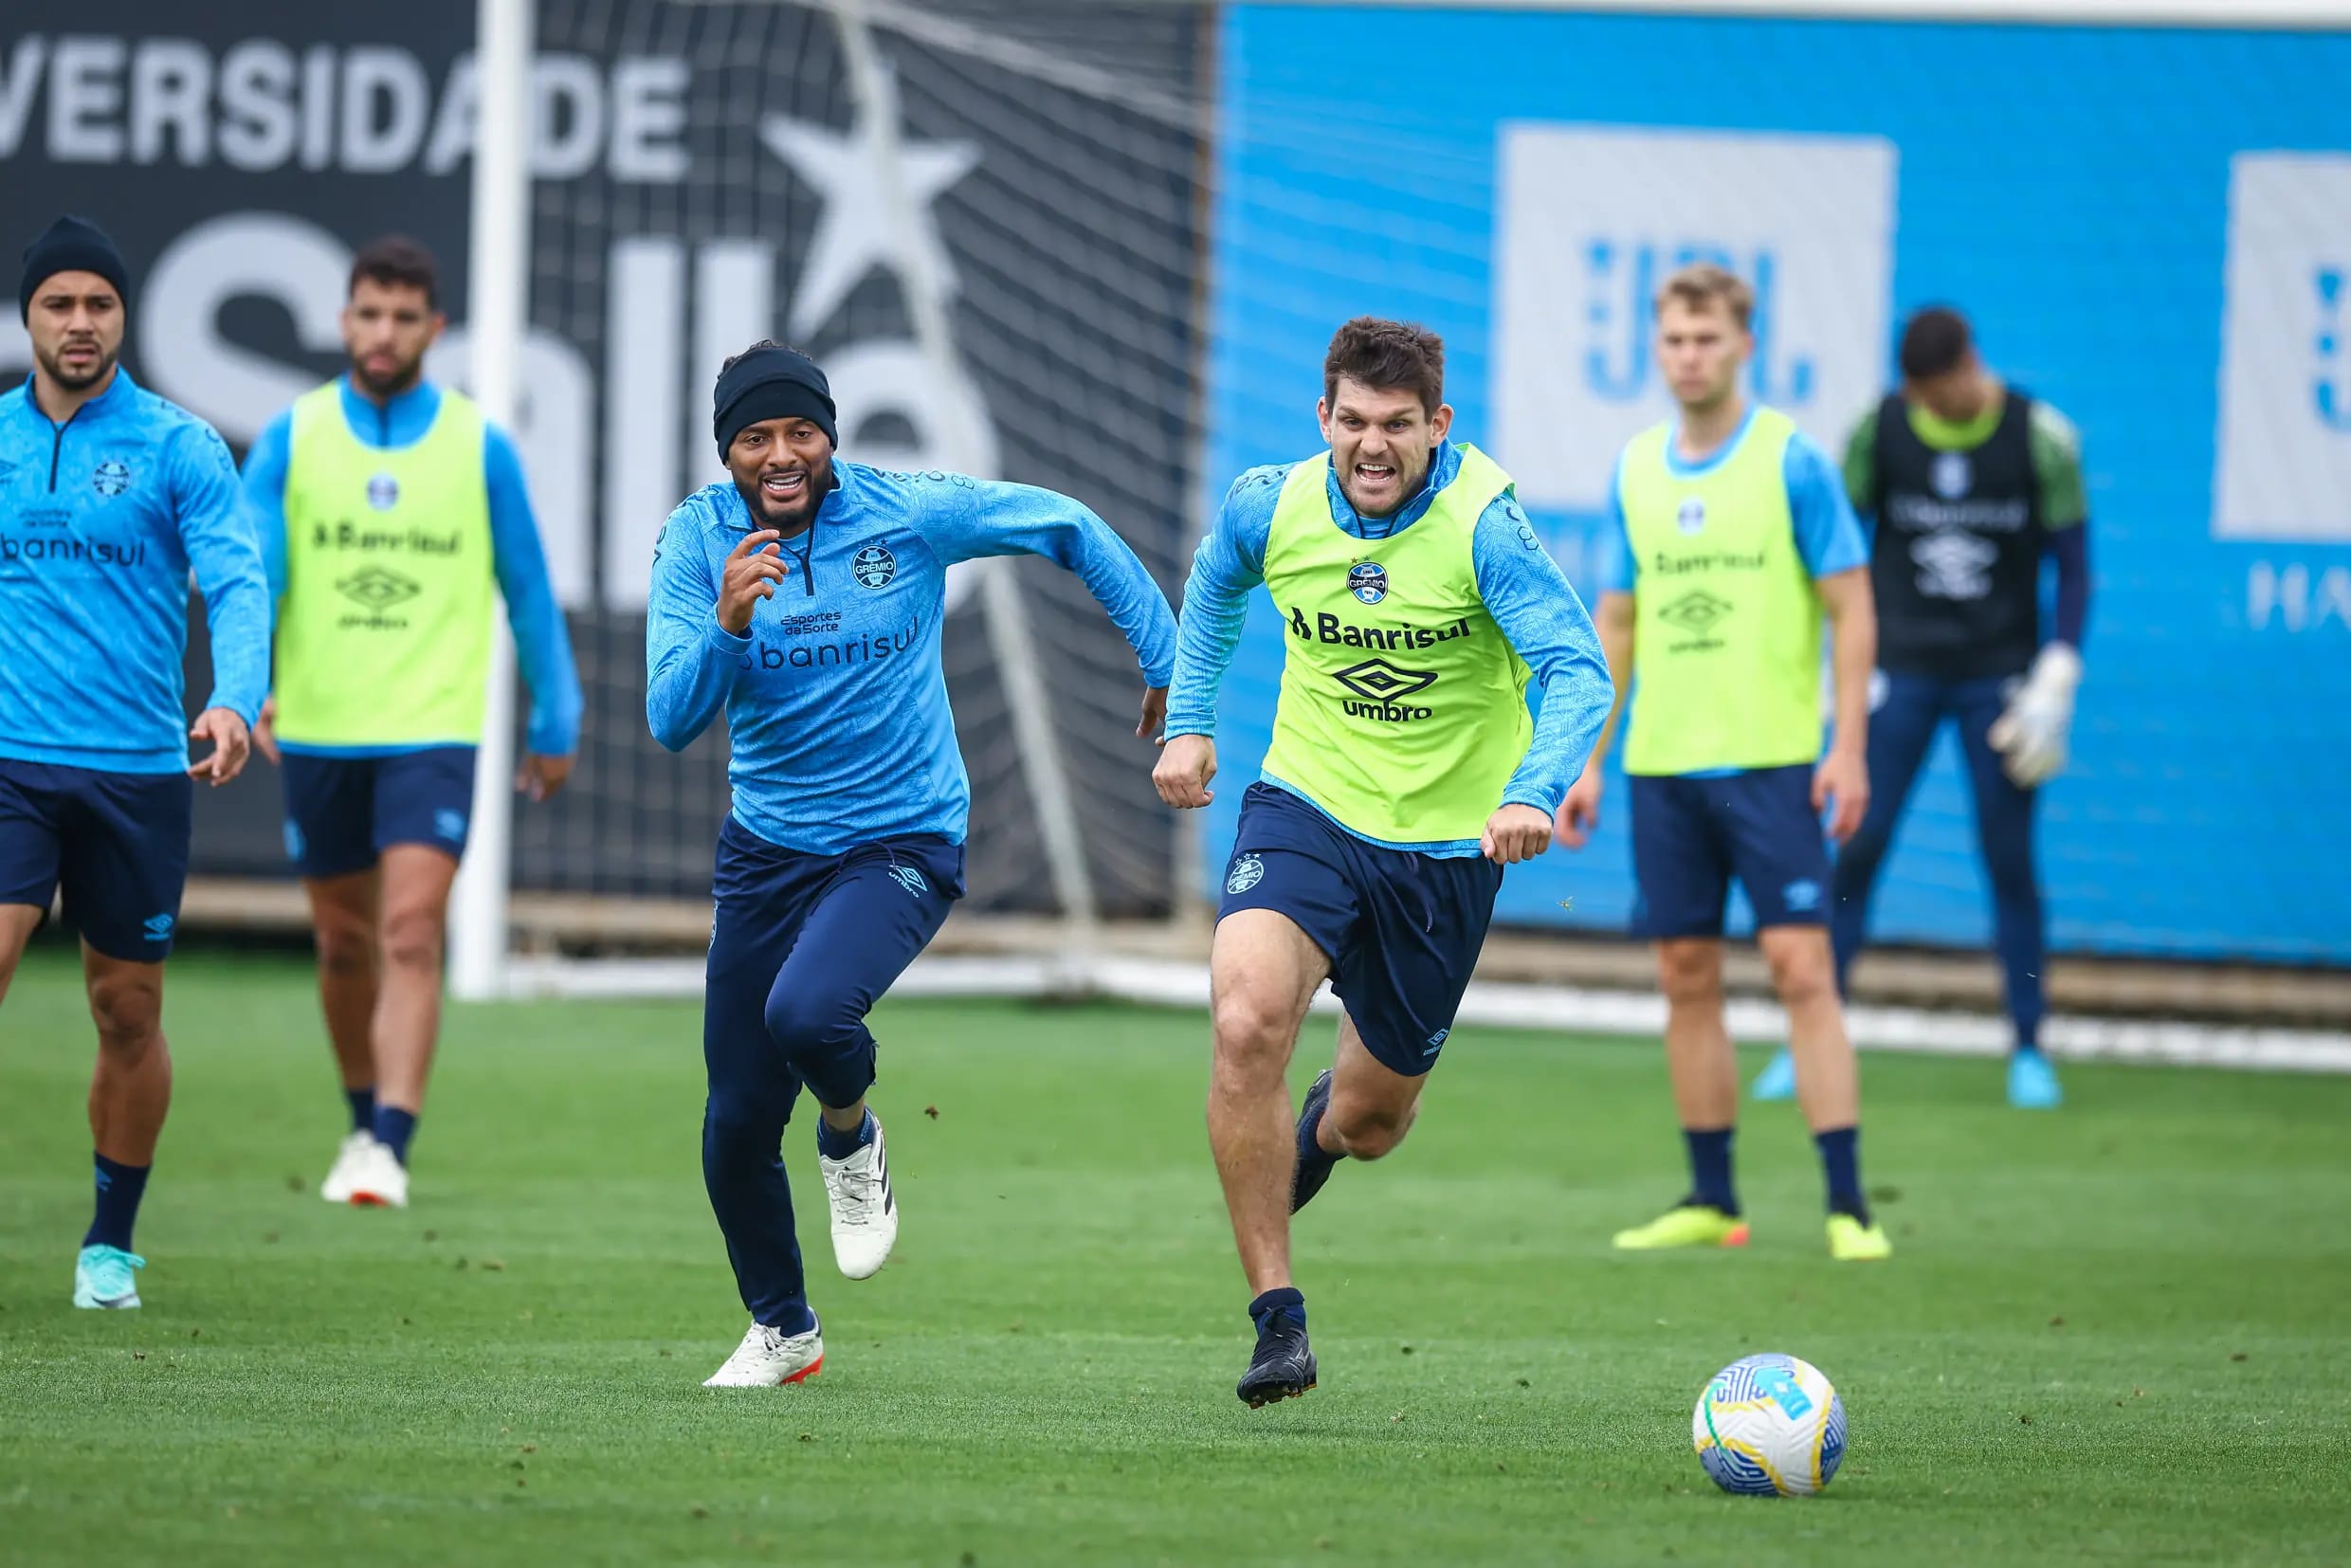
left=1215, top=783, right=1503, bottom=1077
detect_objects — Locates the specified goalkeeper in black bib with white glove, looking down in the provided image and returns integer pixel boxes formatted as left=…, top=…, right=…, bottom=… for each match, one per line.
left=1754, top=305, right=2090, bottom=1109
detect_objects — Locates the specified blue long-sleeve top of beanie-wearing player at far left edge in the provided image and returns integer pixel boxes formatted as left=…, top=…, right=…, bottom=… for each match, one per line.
left=0, top=369, right=270, bottom=774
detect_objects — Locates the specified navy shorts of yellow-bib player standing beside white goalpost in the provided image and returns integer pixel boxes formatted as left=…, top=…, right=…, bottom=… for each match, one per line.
left=282, top=745, right=475, bottom=877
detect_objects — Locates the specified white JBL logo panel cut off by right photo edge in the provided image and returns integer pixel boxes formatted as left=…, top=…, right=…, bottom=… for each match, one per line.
left=2213, top=153, right=2351, bottom=540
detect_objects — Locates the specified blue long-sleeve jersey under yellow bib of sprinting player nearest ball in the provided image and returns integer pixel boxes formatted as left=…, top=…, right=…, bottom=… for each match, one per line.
left=1166, top=442, right=1615, bottom=856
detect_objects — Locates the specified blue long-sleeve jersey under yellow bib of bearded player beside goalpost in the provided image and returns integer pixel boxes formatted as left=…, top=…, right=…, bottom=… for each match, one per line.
left=245, top=376, right=583, bottom=757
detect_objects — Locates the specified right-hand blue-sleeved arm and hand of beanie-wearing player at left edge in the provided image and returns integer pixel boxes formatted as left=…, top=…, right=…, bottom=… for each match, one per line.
left=167, top=421, right=270, bottom=785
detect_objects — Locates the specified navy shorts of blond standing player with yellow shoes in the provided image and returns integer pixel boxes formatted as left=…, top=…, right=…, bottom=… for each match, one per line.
left=1627, top=761, right=1829, bottom=940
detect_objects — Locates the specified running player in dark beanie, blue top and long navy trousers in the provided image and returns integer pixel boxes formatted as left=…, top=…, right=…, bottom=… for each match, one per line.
left=645, top=343, right=1176, bottom=1387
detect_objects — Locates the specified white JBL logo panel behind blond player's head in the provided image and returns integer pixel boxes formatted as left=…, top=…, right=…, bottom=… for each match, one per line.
left=1493, top=124, right=1895, bottom=510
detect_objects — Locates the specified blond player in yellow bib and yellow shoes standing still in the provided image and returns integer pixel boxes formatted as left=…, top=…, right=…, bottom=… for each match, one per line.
left=1558, top=265, right=1887, bottom=1258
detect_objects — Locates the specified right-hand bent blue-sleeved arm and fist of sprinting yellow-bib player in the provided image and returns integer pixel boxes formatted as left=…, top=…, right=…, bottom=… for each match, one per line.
left=1469, top=496, right=1615, bottom=866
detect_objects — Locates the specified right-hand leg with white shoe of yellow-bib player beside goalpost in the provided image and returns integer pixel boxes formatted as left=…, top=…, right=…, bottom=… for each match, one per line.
left=351, top=844, right=456, bottom=1209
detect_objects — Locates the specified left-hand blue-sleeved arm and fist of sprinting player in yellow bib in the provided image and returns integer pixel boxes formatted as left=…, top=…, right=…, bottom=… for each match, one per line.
left=1152, top=467, right=1288, bottom=807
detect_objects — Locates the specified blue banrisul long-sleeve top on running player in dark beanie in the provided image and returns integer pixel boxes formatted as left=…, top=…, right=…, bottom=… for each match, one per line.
left=645, top=459, right=1176, bottom=856
